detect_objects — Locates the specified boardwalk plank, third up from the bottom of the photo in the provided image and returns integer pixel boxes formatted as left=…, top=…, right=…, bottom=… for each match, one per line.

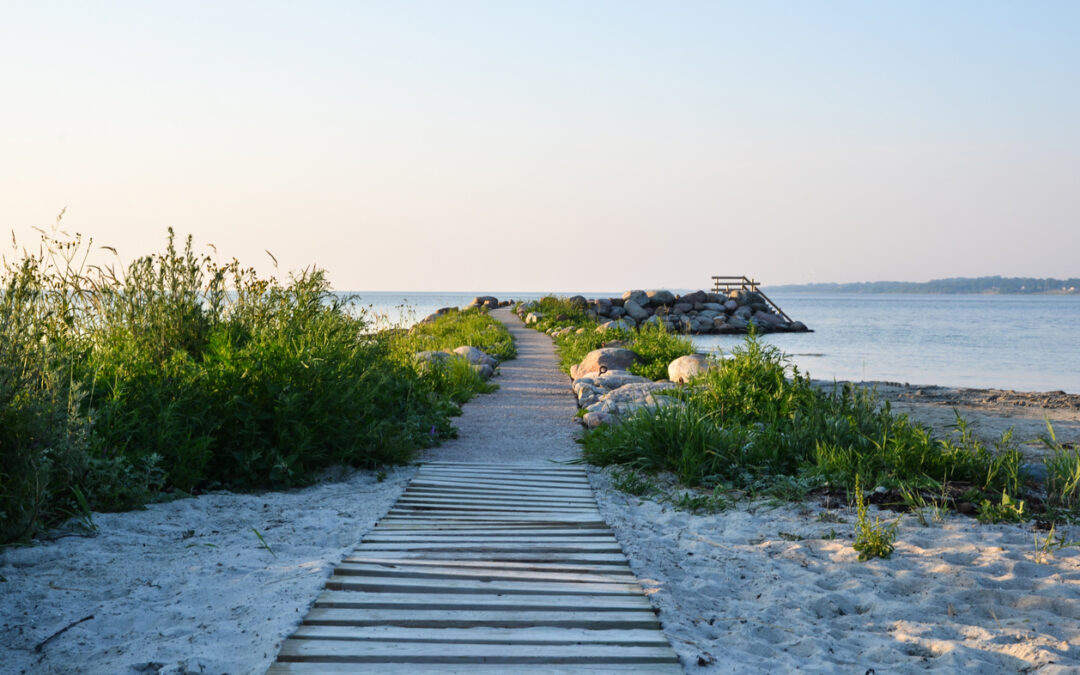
left=293, top=625, right=667, bottom=647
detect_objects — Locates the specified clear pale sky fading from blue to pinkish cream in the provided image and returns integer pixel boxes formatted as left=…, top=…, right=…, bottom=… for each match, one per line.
left=0, top=0, right=1080, bottom=292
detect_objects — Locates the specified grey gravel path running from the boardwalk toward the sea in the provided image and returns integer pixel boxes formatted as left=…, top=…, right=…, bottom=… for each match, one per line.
left=418, top=308, right=581, bottom=463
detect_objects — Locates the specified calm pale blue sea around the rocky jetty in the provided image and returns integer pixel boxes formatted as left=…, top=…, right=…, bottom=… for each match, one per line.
left=347, top=293, right=1080, bottom=393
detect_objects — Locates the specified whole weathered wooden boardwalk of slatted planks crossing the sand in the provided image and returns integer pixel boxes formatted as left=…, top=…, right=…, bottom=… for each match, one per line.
left=269, top=462, right=683, bottom=674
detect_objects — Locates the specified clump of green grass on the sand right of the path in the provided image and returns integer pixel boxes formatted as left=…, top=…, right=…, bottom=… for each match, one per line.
left=583, top=335, right=1023, bottom=516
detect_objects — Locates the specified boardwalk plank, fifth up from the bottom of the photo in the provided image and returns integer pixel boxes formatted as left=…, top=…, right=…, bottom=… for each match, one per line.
left=314, top=591, right=652, bottom=612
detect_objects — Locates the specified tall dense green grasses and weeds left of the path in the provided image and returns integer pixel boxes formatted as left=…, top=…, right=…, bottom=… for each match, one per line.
left=0, top=223, right=513, bottom=543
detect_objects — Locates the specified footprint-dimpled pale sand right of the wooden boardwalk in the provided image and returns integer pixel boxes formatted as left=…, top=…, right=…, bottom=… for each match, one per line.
left=592, top=471, right=1080, bottom=673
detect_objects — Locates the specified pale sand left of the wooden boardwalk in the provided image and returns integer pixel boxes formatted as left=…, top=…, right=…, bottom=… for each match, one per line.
left=0, top=468, right=415, bottom=675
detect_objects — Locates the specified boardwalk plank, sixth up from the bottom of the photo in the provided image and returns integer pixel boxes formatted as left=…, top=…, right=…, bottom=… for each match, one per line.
left=326, top=575, right=642, bottom=595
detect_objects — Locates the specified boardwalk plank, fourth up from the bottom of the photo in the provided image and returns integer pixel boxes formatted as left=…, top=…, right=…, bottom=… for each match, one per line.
left=303, top=607, right=659, bottom=631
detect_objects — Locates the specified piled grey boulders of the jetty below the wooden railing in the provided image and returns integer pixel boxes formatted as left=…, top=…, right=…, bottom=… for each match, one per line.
left=518, top=289, right=809, bottom=335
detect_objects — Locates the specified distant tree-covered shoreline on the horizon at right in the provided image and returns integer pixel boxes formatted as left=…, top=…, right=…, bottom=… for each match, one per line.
left=768, top=276, right=1080, bottom=294
